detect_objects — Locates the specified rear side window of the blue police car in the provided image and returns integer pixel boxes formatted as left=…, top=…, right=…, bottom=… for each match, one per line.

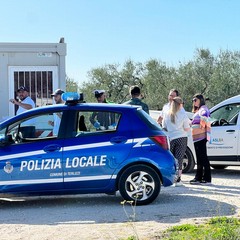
left=76, top=111, right=120, bottom=136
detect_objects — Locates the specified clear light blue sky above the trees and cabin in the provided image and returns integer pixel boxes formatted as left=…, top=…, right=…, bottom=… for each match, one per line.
left=0, top=0, right=240, bottom=85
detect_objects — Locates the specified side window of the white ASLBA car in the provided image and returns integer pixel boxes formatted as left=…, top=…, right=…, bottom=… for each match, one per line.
left=211, top=104, right=240, bottom=126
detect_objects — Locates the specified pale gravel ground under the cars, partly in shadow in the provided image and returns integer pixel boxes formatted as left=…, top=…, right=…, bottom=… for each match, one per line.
left=0, top=167, right=240, bottom=240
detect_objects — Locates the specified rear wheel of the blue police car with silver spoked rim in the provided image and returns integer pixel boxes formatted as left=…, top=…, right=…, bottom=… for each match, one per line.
left=118, top=165, right=161, bottom=205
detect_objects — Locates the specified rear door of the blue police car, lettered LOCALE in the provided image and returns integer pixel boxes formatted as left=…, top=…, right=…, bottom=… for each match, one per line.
left=63, top=111, right=131, bottom=191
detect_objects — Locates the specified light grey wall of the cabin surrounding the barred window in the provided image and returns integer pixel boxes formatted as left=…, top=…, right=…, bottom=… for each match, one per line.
left=0, top=42, right=66, bottom=121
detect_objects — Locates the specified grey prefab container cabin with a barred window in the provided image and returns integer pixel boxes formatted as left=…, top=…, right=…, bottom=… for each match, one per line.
left=0, top=38, right=66, bottom=121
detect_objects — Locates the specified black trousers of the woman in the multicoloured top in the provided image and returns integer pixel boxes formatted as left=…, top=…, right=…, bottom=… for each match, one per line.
left=194, top=139, right=212, bottom=182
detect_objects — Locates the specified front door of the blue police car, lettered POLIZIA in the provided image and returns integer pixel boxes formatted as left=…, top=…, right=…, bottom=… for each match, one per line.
left=0, top=114, right=63, bottom=195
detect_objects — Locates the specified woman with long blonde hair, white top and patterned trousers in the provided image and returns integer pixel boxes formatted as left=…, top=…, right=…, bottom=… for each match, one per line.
left=162, top=97, right=190, bottom=186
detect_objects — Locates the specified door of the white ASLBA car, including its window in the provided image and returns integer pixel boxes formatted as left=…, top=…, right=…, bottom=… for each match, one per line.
left=207, top=104, right=240, bottom=165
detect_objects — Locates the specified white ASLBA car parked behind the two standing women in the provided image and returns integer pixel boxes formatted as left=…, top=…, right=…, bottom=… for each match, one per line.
left=150, top=95, right=240, bottom=173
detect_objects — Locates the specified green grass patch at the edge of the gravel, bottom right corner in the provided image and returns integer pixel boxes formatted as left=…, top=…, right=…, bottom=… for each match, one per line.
left=158, top=217, right=240, bottom=240
